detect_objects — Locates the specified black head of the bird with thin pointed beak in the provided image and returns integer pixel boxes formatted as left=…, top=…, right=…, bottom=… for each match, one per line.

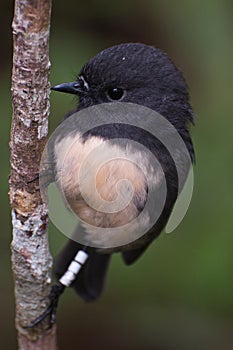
left=52, top=43, right=193, bottom=129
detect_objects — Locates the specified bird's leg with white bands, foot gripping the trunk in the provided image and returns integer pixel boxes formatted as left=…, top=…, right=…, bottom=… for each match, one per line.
left=26, top=250, right=88, bottom=328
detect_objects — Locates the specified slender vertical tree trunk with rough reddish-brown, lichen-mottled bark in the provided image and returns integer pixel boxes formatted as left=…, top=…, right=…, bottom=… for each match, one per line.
left=9, top=0, right=56, bottom=350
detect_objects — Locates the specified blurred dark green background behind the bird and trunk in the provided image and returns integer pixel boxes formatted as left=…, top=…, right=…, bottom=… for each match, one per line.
left=0, top=0, right=233, bottom=350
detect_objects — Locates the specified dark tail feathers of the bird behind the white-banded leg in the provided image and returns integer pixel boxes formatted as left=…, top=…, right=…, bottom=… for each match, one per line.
left=55, top=240, right=111, bottom=301
